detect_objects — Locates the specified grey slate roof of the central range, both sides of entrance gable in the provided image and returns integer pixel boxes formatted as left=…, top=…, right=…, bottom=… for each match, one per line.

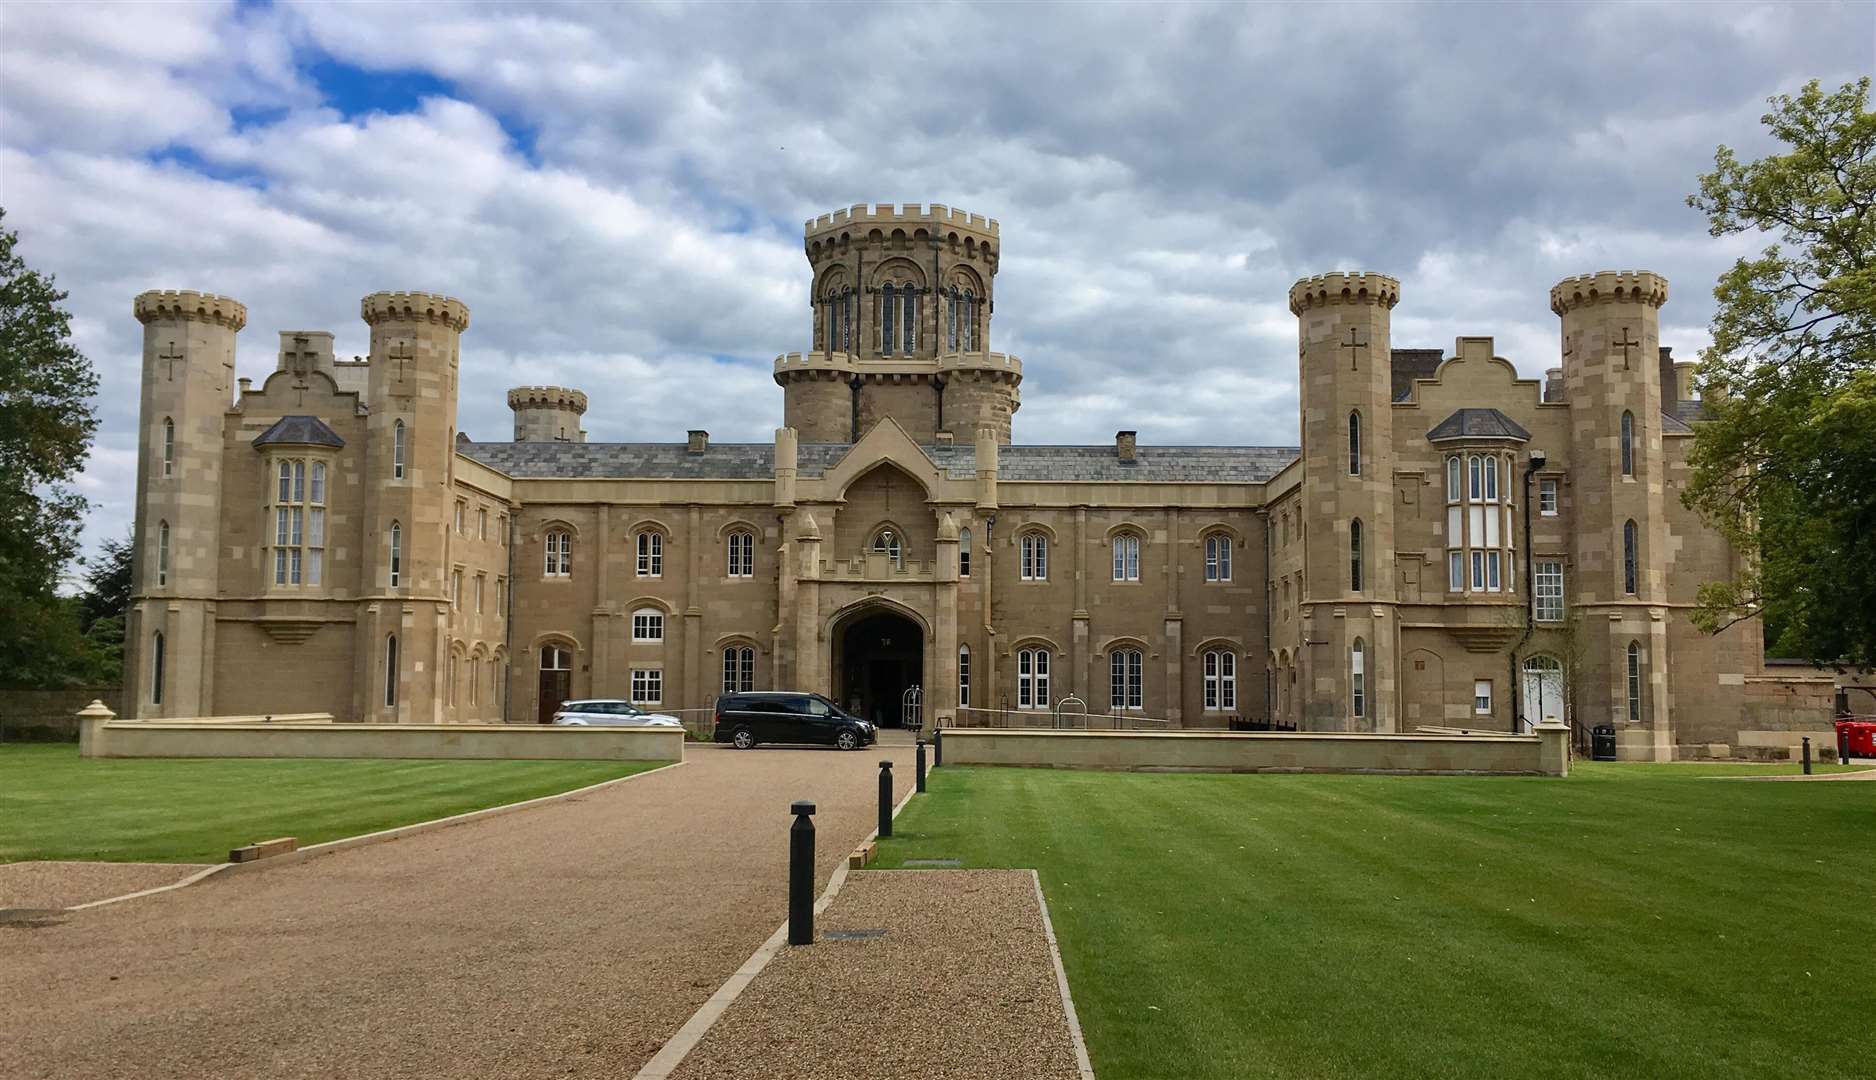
left=458, top=443, right=1298, bottom=484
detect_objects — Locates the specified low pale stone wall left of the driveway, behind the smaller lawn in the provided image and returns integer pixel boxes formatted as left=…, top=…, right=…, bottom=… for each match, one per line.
left=81, top=718, right=685, bottom=761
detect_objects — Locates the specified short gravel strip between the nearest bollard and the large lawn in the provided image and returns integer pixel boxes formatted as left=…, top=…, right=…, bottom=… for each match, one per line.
left=672, top=870, right=1081, bottom=1080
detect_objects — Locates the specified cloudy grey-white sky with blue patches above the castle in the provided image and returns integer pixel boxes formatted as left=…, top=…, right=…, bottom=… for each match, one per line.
left=0, top=2, right=1876, bottom=544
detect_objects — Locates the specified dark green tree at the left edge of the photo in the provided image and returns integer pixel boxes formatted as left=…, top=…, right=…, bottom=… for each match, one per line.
left=0, top=210, right=98, bottom=686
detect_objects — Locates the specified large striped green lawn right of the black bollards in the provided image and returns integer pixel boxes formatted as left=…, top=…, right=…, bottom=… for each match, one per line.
left=880, top=765, right=1876, bottom=1080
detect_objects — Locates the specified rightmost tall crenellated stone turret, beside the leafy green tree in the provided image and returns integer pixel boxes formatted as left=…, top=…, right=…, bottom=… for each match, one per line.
left=1550, top=270, right=1673, bottom=759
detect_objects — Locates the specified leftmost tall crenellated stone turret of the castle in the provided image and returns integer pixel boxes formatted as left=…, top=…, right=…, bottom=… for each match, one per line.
left=124, top=291, right=248, bottom=716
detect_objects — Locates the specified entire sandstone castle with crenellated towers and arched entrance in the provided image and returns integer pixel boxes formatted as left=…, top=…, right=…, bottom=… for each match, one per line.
left=128, top=204, right=1829, bottom=759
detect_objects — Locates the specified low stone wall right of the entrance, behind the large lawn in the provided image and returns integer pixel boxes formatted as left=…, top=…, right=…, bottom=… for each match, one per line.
left=942, top=724, right=1570, bottom=776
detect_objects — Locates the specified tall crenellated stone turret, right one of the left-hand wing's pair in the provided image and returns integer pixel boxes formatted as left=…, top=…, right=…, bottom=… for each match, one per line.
left=355, top=293, right=469, bottom=722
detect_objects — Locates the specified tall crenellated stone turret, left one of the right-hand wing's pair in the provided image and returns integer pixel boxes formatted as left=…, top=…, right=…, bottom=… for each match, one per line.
left=1289, top=272, right=1401, bottom=731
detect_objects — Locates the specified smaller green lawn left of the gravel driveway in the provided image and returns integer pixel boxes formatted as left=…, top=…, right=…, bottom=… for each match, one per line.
left=0, top=744, right=657, bottom=863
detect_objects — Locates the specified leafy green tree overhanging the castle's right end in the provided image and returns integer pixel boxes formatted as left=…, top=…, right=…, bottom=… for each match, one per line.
left=1681, top=77, right=1876, bottom=666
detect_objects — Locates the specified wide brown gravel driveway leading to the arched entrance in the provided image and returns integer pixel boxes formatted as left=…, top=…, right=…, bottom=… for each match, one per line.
left=0, top=746, right=912, bottom=1080
